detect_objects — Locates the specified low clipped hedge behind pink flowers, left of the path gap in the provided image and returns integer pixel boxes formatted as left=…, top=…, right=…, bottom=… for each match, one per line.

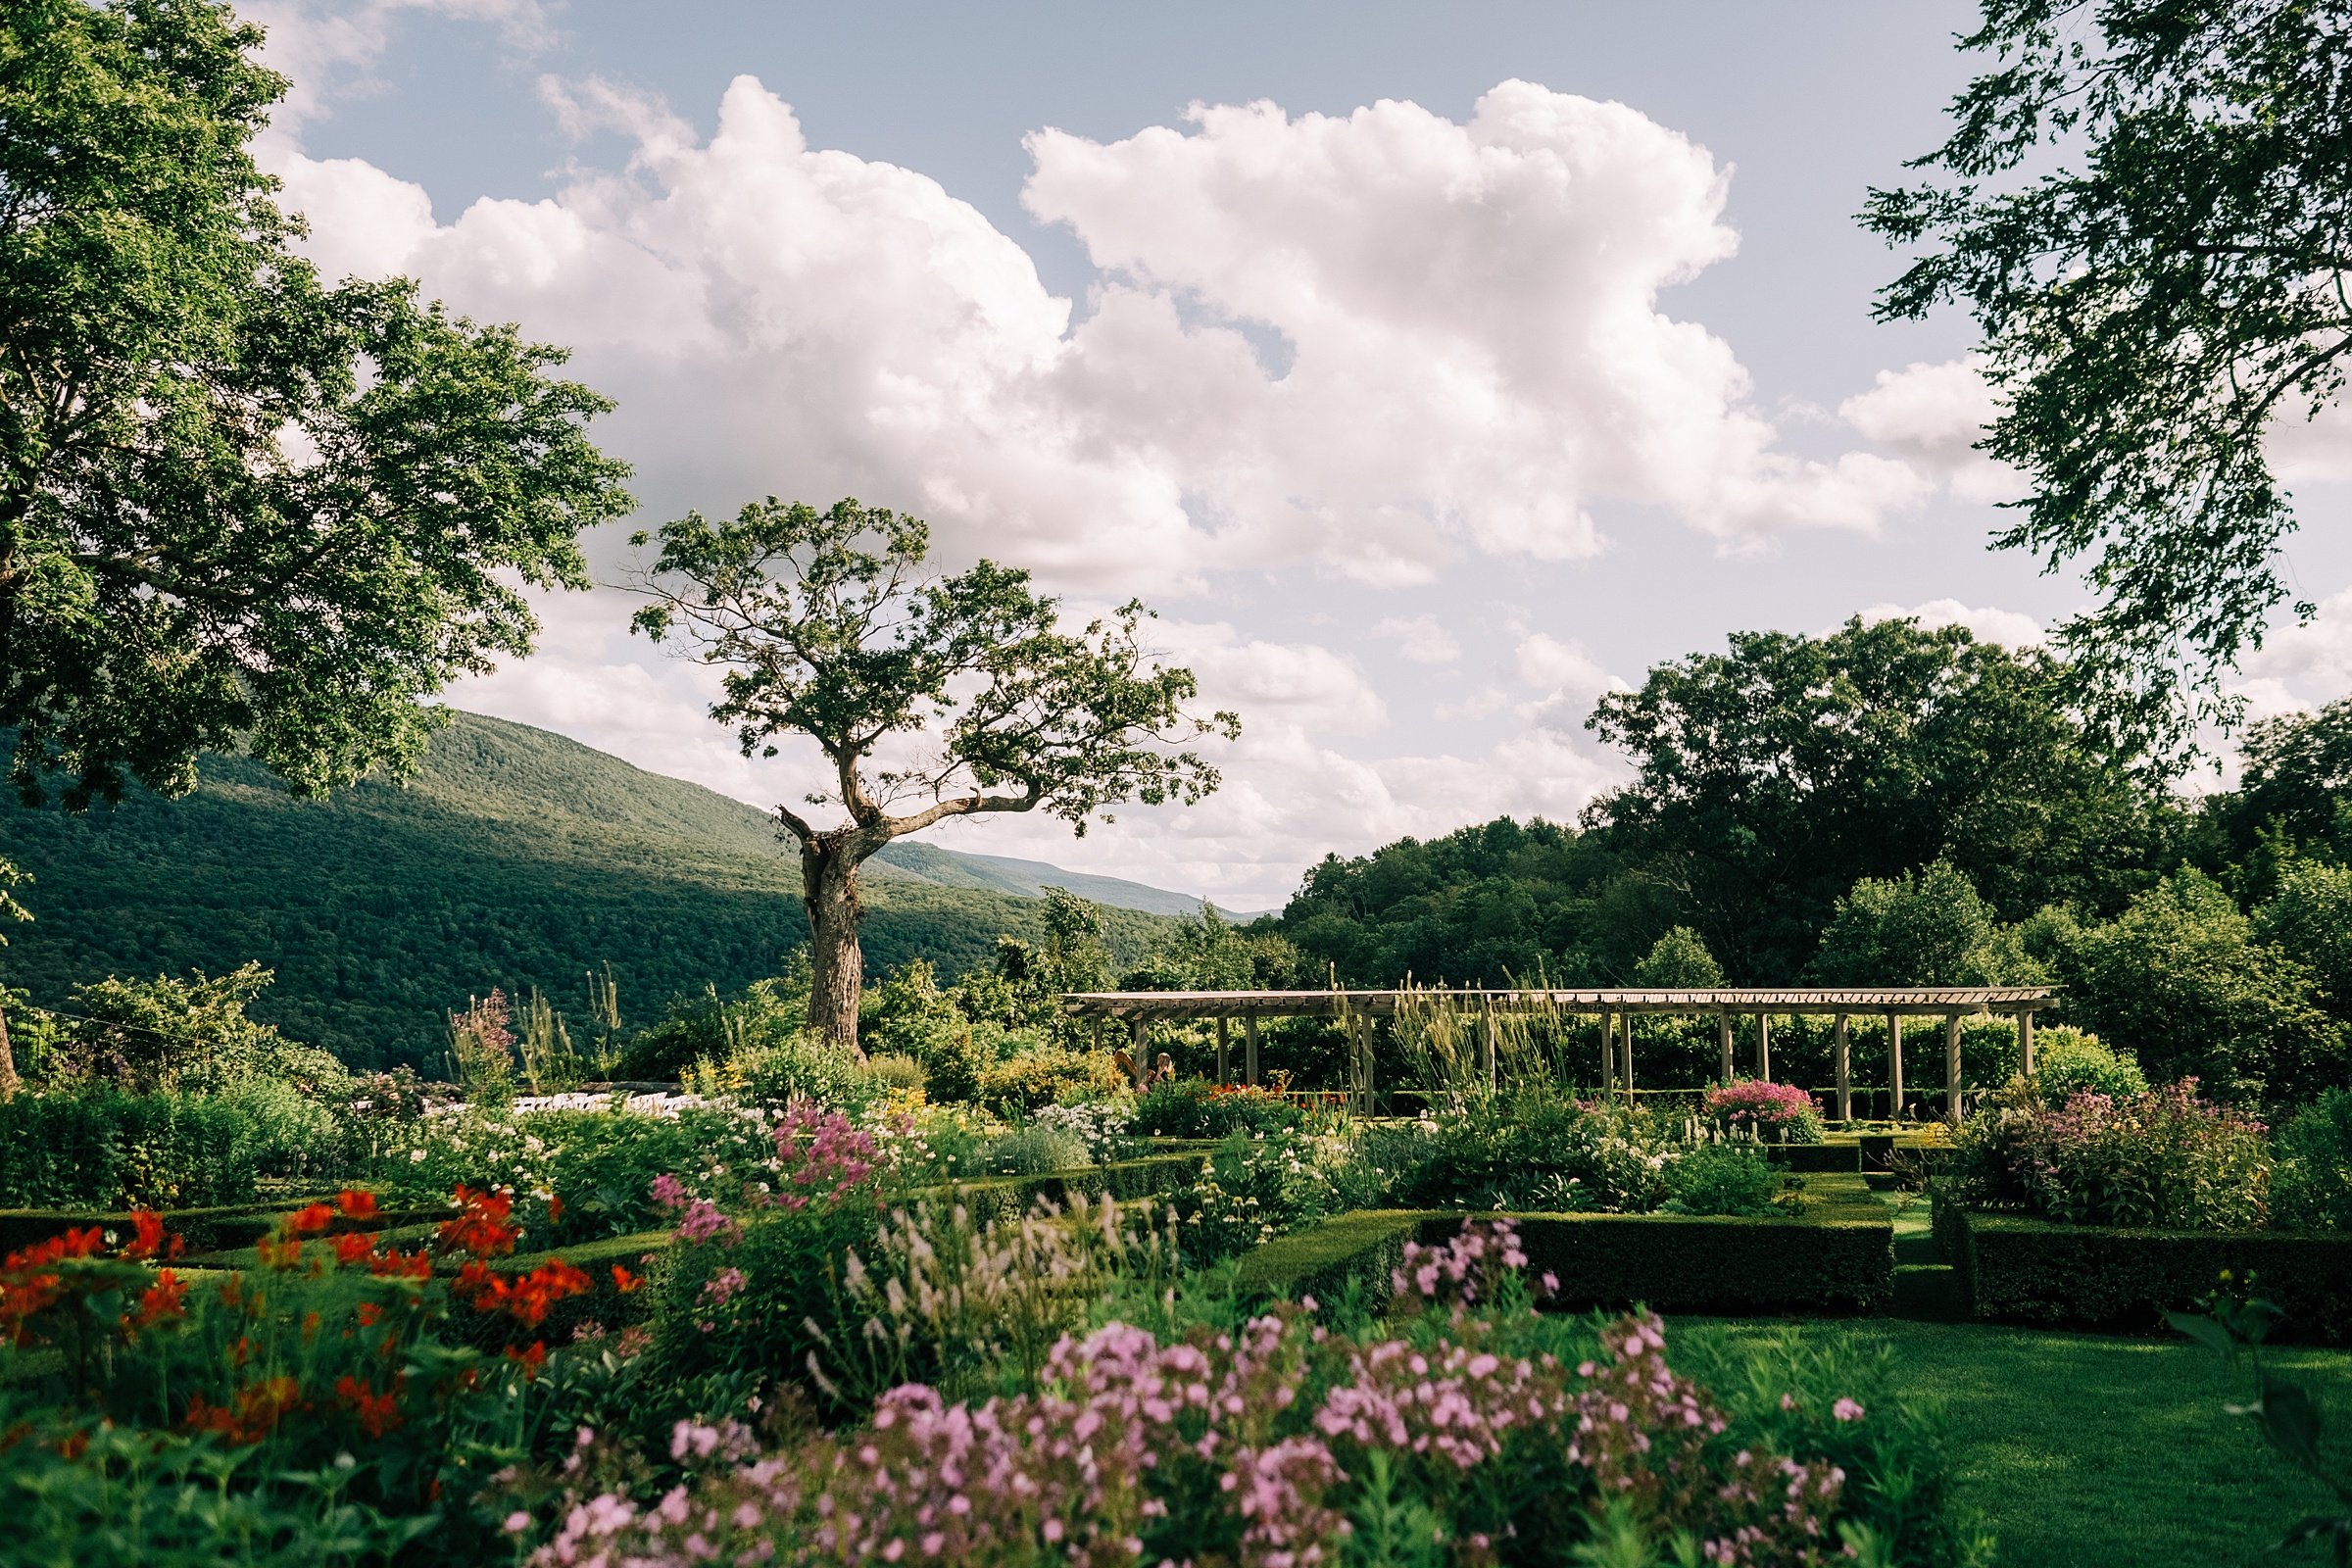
left=1237, top=1173, right=1895, bottom=1312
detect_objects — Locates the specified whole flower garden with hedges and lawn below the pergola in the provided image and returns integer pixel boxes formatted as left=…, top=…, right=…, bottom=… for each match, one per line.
left=0, top=955, right=2352, bottom=1568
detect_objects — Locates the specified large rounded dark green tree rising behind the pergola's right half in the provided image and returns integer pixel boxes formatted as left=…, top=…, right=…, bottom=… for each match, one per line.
left=1586, top=618, right=2159, bottom=983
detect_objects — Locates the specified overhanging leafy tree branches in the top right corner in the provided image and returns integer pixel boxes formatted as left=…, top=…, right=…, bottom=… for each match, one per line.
left=1863, top=0, right=2352, bottom=743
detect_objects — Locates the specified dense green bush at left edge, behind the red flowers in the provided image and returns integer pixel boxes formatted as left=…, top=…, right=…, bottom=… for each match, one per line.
left=0, top=1089, right=272, bottom=1208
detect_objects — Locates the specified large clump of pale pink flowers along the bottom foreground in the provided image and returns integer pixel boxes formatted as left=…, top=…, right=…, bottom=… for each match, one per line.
left=534, top=1222, right=1860, bottom=1568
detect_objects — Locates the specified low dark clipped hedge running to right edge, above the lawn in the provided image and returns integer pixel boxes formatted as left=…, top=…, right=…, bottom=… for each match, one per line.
left=1936, top=1195, right=2352, bottom=1345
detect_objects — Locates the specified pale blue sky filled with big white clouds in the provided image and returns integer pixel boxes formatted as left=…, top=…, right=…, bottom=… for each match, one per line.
left=245, top=0, right=2352, bottom=912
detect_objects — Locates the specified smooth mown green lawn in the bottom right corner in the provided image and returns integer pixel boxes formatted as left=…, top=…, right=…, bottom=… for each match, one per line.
left=1693, top=1319, right=2352, bottom=1568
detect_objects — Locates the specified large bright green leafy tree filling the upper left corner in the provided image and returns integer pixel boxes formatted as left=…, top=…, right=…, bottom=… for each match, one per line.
left=0, top=0, right=630, bottom=808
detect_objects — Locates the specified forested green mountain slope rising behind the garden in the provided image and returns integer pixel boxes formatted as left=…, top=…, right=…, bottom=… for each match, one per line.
left=0, top=712, right=1188, bottom=1067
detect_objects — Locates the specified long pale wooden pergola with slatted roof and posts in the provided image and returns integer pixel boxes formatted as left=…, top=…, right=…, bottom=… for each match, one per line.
left=1060, top=985, right=2056, bottom=1121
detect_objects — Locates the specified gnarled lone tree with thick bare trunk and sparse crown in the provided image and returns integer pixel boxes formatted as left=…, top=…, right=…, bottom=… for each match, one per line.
left=635, top=496, right=1240, bottom=1046
